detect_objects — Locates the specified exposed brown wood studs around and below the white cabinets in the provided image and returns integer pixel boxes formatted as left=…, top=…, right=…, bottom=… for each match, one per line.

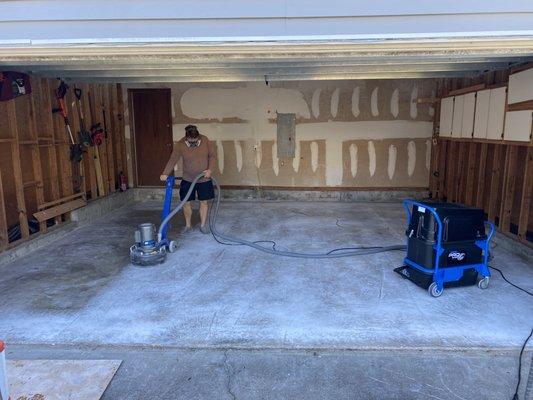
left=430, top=66, right=533, bottom=247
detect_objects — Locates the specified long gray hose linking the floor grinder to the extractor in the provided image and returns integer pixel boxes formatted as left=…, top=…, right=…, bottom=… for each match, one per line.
left=157, top=173, right=406, bottom=259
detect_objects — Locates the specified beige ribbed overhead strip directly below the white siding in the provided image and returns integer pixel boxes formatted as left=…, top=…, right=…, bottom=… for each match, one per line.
left=0, top=38, right=533, bottom=82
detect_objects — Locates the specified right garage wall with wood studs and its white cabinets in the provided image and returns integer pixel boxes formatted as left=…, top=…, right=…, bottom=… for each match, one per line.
left=430, top=64, right=533, bottom=247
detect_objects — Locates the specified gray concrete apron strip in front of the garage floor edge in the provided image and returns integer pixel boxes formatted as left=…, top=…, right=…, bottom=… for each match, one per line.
left=7, top=345, right=533, bottom=400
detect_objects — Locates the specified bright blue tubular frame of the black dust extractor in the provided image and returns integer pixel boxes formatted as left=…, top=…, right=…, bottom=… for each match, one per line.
left=403, top=200, right=495, bottom=291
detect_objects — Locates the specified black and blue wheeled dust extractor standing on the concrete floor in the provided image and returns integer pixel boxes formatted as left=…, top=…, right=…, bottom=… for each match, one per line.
left=395, top=200, right=494, bottom=297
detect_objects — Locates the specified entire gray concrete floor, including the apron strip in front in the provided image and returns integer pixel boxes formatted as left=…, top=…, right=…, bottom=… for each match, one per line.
left=0, top=201, right=533, bottom=399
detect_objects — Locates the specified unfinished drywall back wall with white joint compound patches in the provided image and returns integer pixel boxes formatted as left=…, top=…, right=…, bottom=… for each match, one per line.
left=124, top=80, right=435, bottom=189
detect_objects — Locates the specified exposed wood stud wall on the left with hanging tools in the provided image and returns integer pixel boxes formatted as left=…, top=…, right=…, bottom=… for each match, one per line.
left=0, top=78, right=126, bottom=251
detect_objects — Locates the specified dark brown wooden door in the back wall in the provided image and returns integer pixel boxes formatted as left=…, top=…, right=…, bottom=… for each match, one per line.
left=129, top=89, right=172, bottom=186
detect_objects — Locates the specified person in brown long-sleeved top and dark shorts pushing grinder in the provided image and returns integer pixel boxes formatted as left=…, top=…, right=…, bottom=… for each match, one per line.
left=160, top=125, right=215, bottom=233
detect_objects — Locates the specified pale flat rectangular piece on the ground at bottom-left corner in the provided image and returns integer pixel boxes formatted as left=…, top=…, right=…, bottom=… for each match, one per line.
left=7, top=360, right=122, bottom=400
